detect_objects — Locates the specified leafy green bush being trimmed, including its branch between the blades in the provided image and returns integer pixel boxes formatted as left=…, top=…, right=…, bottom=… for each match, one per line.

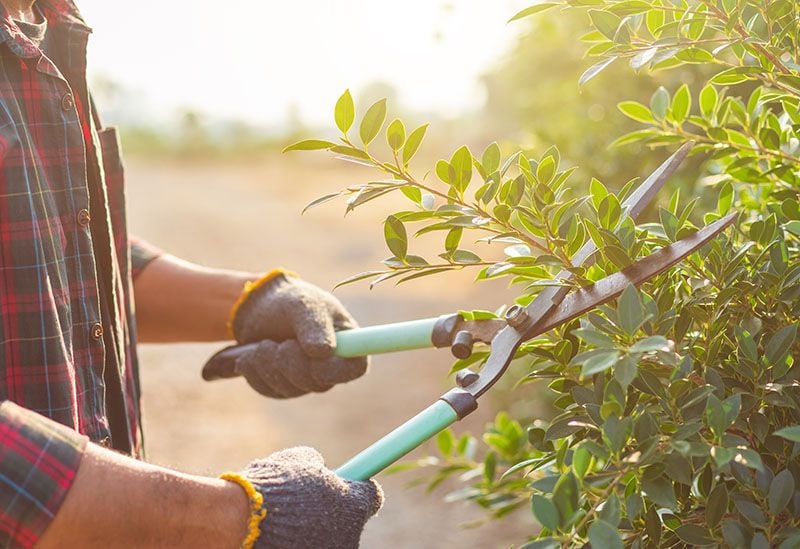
left=282, top=0, right=800, bottom=548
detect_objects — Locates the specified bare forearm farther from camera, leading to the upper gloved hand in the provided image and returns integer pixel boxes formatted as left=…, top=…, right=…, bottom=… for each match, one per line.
left=134, top=255, right=258, bottom=343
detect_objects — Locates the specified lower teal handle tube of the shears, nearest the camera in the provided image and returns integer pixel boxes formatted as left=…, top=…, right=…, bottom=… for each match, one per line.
left=336, top=400, right=458, bottom=480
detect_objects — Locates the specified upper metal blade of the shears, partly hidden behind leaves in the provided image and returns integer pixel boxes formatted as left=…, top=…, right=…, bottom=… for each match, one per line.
left=525, top=142, right=694, bottom=325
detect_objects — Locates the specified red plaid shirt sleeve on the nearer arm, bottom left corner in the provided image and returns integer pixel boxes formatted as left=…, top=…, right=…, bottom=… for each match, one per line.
left=0, top=401, right=88, bottom=548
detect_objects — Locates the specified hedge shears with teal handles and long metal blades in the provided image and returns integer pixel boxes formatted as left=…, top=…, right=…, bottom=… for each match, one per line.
left=203, top=144, right=737, bottom=480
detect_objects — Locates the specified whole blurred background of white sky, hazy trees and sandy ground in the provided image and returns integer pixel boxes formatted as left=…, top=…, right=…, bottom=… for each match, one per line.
left=78, top=0, right=708, bottom=548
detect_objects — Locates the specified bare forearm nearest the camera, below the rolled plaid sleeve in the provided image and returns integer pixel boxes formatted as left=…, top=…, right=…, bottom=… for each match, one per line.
left=37, top=444, right=249, bottom=549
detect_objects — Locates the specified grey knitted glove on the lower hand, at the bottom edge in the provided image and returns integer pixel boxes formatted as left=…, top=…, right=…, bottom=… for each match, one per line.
left=242, top=448, right=383, bottom=549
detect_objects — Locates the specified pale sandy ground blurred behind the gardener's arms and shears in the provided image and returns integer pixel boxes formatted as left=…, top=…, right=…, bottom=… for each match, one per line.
left=127, top=155, right=535, bottom=548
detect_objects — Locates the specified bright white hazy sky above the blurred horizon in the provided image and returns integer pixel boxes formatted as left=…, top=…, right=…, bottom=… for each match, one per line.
left=77, top=0, right=533, bottom=124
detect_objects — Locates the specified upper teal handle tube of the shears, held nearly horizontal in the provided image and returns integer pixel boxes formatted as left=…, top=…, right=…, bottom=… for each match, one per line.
left=336, top=318, right=439, bottom=358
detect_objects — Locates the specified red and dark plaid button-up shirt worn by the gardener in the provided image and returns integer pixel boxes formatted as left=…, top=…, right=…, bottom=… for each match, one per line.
left=0, top=0, right=161, bottom=547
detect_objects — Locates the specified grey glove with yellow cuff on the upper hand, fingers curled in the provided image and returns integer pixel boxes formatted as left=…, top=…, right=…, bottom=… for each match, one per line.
left=231, top=270, right=368, bottom=398
